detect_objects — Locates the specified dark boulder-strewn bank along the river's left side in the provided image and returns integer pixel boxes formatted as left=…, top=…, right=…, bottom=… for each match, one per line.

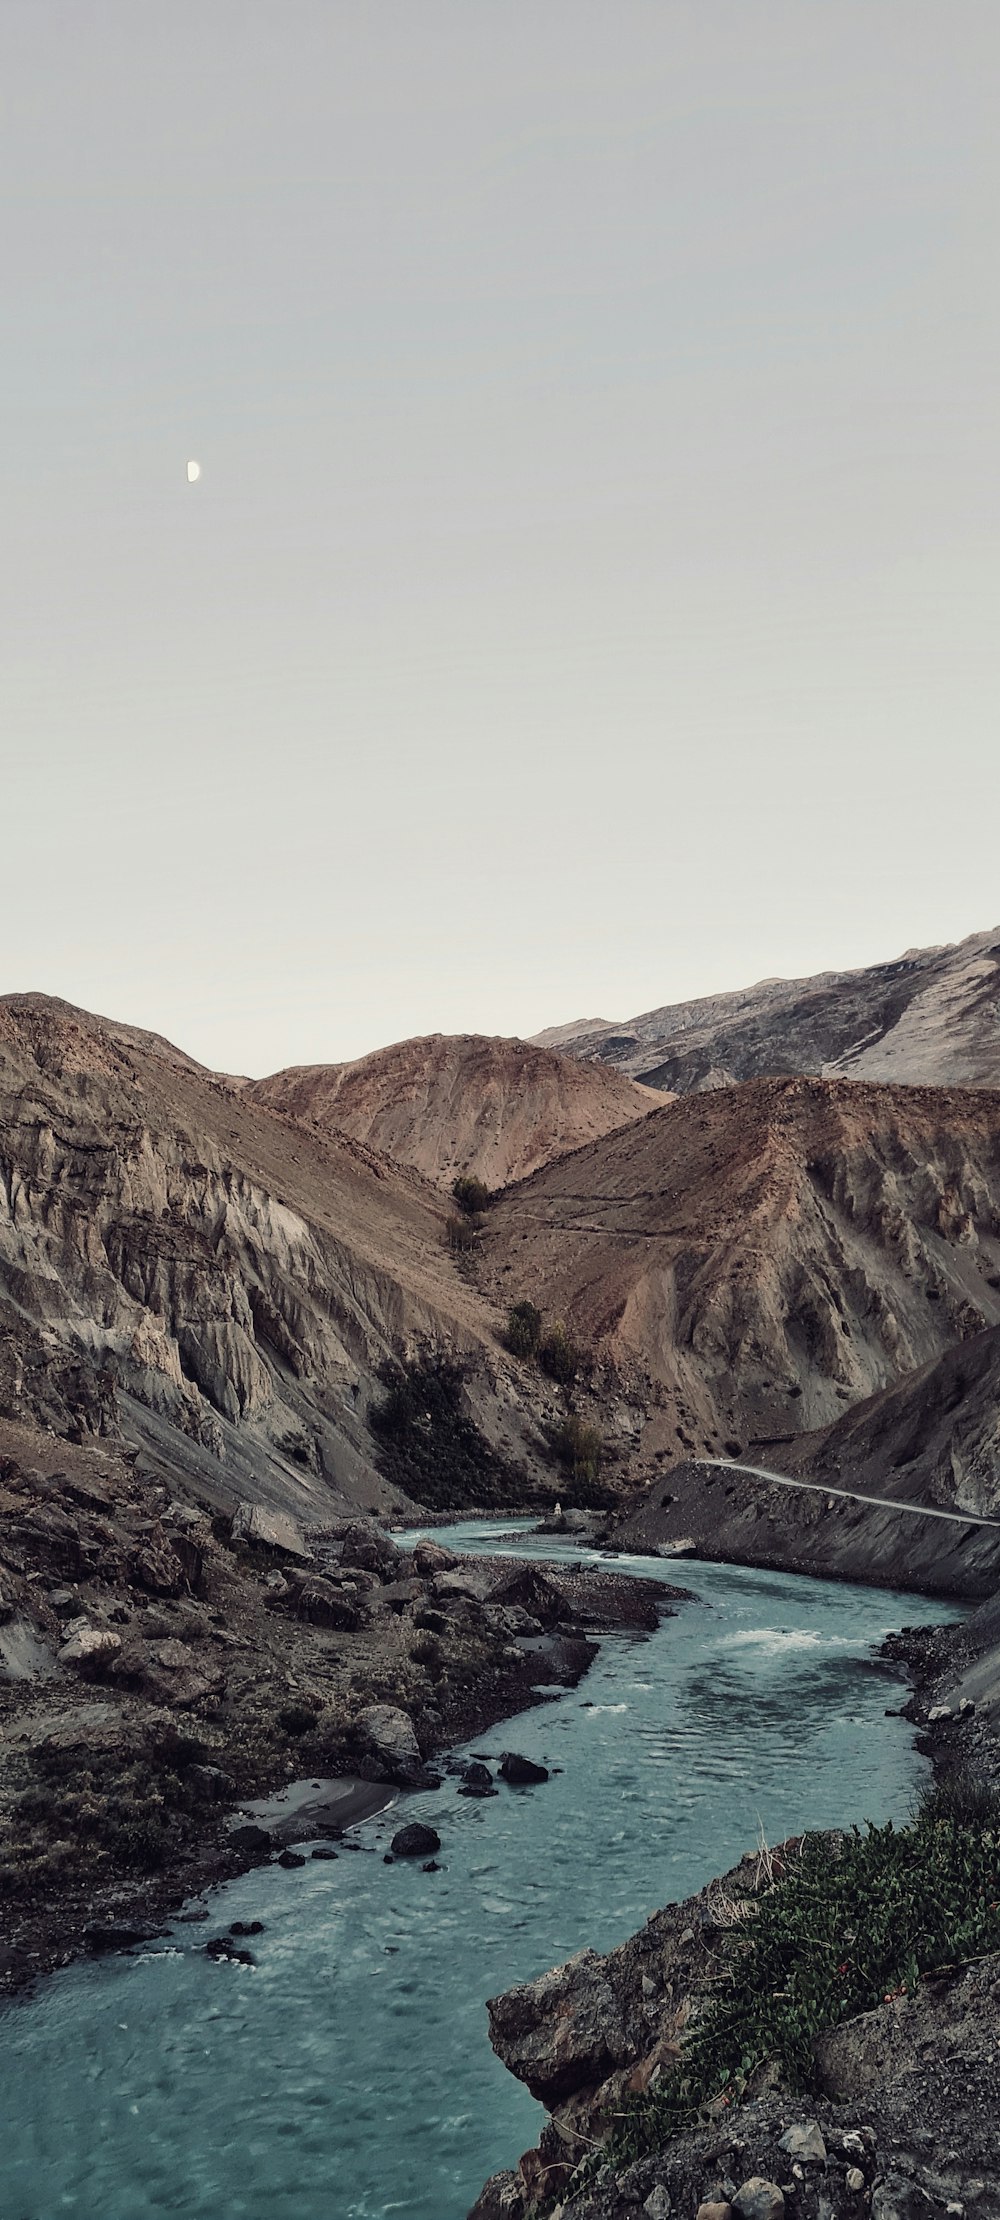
left=0, top=1434, right=684, bottom=1994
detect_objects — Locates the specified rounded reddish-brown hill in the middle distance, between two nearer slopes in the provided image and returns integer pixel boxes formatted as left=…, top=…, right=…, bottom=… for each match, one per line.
left=247, top=1032, right=662, bottom=1188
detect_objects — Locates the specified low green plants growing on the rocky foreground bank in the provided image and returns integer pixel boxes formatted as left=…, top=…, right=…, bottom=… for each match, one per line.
left=573, top=1789, right=1000, bottom=2191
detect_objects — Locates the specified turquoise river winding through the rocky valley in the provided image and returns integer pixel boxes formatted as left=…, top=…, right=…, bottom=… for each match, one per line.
left=0, top=1521, right=956, bottom=2220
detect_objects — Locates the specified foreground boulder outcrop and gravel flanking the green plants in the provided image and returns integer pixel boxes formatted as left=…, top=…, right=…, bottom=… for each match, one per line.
left=469, top=1856, right=1000, bottom=2220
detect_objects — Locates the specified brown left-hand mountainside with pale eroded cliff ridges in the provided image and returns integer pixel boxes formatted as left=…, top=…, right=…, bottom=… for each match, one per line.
left=0, top=995, right=546, bottom=1516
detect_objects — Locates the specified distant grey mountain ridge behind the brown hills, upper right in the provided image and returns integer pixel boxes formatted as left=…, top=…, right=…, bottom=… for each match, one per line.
left=538, top=928, right=1000, bottom=1094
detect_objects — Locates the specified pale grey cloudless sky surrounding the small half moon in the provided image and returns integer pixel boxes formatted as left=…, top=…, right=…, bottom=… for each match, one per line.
left=0, top=0, right=1000, bottom=1074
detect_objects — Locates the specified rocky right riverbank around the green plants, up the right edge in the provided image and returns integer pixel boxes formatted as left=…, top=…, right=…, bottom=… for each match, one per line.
left=471, top=1603, right=1000, bottom=2220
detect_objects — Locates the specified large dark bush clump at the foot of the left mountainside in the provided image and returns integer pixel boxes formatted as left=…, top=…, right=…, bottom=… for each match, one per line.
left=369, top=1354, right=540, bottom=1512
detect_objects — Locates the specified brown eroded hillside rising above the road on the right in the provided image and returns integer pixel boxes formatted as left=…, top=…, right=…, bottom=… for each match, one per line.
left=482, top=1079, right=1000, bottom=1459
